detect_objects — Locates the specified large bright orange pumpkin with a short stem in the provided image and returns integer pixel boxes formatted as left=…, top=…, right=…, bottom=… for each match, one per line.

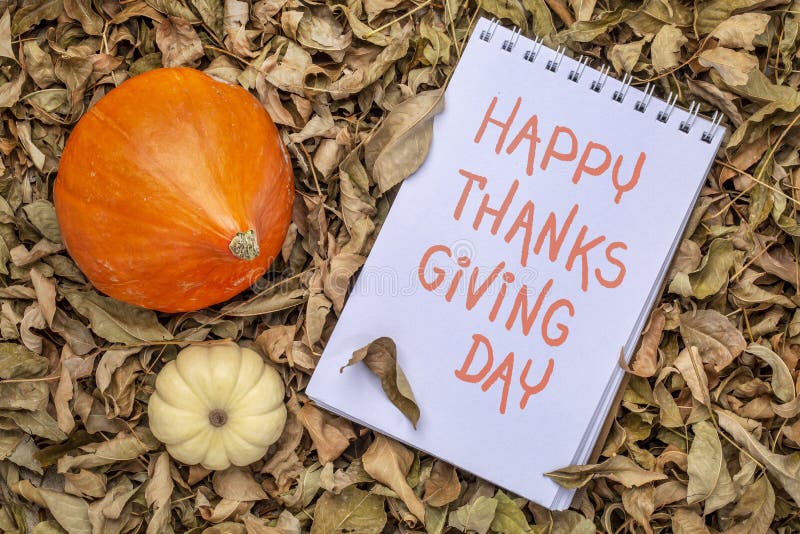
left=54, top=68, right=294, bottom=312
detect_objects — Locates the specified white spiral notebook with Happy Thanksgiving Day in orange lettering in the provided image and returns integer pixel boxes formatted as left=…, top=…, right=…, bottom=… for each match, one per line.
left=307, top=19, right=725, bottom=509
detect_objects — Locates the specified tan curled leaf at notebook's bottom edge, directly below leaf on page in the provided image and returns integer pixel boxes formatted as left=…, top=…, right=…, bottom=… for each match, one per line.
left=361, top=434, right=425, bottom=521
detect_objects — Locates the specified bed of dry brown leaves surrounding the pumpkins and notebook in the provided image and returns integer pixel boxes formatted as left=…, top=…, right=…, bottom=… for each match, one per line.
left=0, top=0, right=800, bottom=534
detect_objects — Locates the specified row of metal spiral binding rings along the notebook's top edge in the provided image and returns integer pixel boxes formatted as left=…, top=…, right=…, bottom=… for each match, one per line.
left=479, top=18, right=723, bottom=143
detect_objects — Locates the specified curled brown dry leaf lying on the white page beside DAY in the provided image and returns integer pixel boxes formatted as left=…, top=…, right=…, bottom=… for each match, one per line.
left=340, top=337, right=420, bottom=428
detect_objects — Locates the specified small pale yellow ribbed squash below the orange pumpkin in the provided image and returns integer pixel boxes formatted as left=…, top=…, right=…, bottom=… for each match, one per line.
left=148, top=343, right=286, bottom=469
